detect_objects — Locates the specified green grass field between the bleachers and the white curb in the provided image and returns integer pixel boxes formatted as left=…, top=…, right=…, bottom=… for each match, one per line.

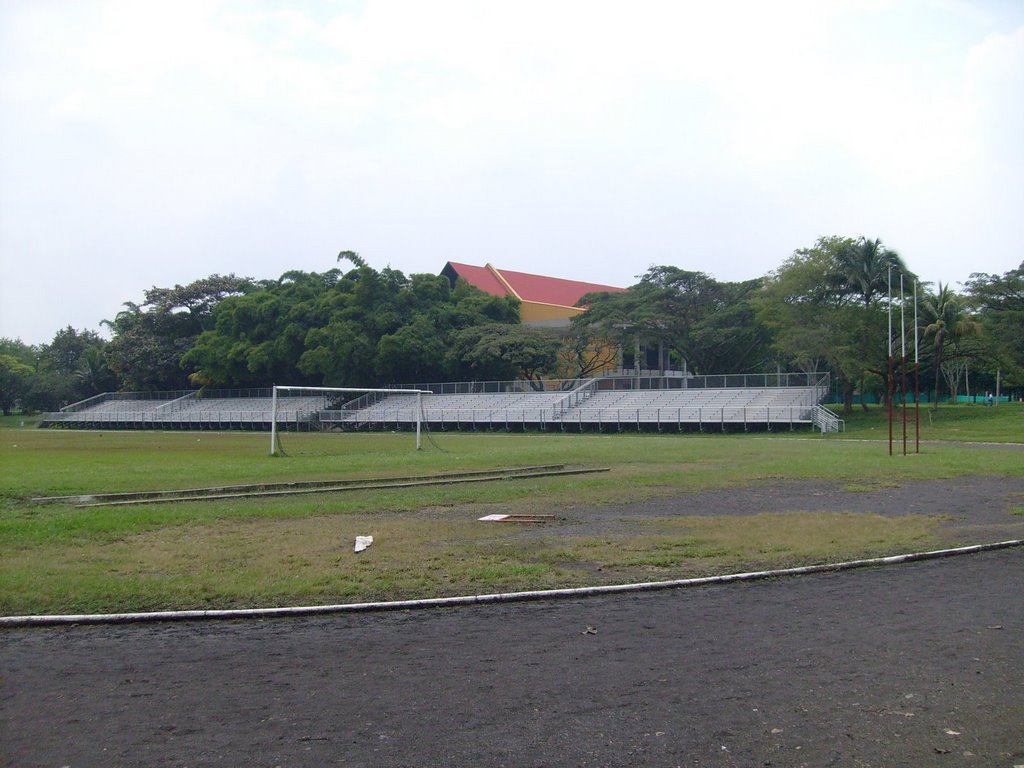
left=0, top=404, right=1024, bottom=614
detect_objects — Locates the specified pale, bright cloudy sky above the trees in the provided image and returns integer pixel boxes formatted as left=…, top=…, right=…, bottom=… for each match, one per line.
left=0, top=0, right=1024, bottom=344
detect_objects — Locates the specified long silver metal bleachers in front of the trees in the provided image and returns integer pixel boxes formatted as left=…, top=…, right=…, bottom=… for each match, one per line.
left=41, top=374, right=842, bottom=431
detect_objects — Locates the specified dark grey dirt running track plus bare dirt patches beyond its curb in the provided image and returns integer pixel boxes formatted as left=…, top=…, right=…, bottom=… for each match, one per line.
left=0, top=480, right=1024, bottom=768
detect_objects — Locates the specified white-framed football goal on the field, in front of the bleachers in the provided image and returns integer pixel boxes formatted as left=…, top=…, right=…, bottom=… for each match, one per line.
left=270, top=385, right=430, bottom=456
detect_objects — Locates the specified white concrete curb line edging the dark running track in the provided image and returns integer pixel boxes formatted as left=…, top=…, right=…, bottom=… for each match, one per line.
left=0, top=539, right=1024, bottom=628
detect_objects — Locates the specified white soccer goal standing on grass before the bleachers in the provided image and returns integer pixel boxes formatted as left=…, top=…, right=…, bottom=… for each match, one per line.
left=270, top=384, right=431, bottom=456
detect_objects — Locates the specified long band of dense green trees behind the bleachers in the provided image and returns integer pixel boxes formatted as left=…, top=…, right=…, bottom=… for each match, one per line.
left=0, top=247, right=1024, bottom=414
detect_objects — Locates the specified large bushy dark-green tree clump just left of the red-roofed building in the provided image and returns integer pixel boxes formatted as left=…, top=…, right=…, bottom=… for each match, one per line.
left=182, top=264, right=518, bottom=387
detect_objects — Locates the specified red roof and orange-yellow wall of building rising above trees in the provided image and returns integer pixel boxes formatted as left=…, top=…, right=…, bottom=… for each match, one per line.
left=441, top=261, right=626, bottom=327
